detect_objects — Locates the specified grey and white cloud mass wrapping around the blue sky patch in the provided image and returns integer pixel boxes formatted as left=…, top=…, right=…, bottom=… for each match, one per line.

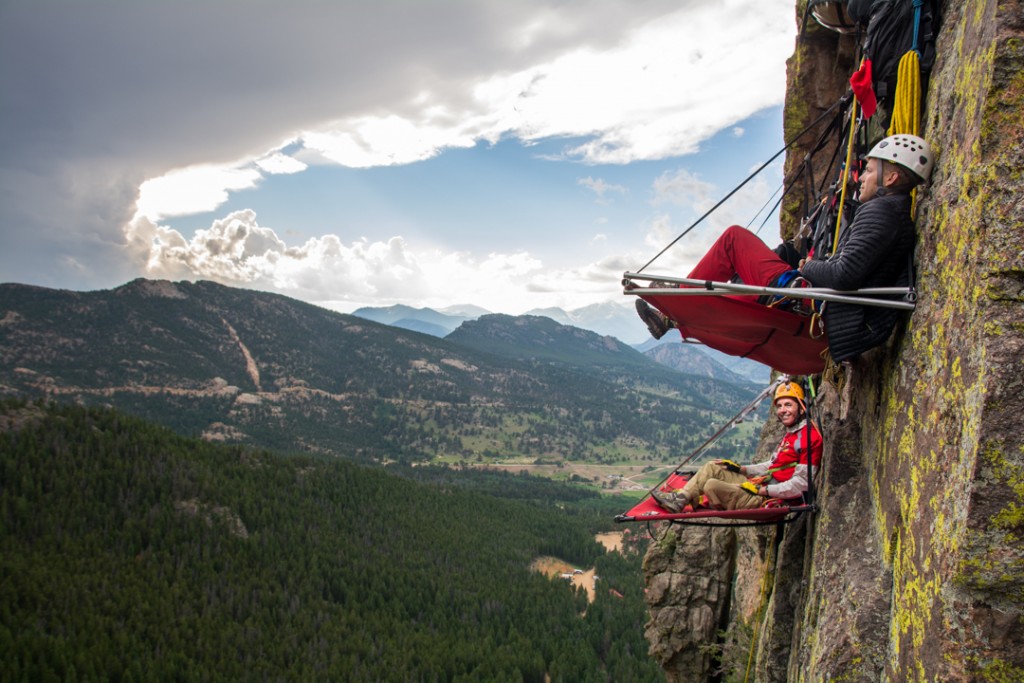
left=0, top=0, right=794, bottom=296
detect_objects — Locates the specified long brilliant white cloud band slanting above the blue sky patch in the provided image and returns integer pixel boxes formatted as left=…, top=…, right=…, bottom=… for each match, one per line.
left=123, top=0, right=793, bottom=222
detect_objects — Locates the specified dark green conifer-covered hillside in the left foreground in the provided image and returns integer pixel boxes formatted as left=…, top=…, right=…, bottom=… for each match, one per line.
left=0, top=401, right=660, bottom=682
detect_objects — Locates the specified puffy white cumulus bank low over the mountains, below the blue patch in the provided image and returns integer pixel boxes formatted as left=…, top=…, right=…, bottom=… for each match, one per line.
left=129, top=210, right=574, bottom=311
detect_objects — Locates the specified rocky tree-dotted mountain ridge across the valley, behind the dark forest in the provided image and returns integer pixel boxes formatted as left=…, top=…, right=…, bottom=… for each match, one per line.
left=0, top=280, right=755, bottom=462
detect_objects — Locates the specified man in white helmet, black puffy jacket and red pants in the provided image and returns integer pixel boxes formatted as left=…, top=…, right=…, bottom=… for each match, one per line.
left=637, top=135, right=934, bottom=361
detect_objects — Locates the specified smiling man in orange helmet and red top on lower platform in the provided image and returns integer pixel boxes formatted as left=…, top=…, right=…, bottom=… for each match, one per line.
left=651, top=382, right=821, bottom=512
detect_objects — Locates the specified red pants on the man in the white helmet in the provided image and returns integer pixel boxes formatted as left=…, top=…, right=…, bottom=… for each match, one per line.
left=688, top=225, right=793, bottom=287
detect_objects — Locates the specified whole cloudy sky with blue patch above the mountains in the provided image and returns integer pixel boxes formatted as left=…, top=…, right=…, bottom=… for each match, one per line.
left=0, top=0, right=797, bottom=314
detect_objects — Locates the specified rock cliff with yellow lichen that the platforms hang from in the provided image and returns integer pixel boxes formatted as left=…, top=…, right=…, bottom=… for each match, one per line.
left=647, top=0, right=1024, bottom=682
